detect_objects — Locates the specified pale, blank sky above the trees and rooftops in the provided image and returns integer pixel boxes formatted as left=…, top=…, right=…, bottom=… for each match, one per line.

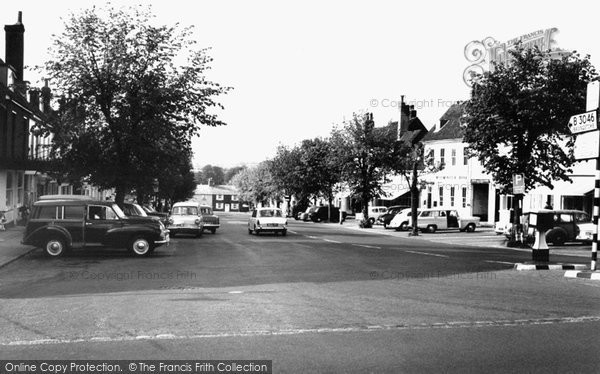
left=0, top=0, right=600, bottom=168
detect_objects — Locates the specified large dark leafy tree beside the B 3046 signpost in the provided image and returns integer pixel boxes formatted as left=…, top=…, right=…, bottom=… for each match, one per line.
left=464, top=46, right=596, bottom=192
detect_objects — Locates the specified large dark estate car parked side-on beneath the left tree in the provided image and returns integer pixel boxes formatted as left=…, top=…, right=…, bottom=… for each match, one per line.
left=22, top=195, right=170, bottom=257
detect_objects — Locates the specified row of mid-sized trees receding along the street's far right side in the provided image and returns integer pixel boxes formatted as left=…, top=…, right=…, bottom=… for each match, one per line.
left=232, top=113, right=424, bottom=225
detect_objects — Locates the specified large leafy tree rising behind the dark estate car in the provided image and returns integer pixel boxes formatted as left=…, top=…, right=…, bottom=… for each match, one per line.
left=38, top=6, right=229, bottom=202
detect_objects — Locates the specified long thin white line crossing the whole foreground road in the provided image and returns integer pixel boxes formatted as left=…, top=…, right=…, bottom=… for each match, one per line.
left=5, top=316, right=600, bottom=346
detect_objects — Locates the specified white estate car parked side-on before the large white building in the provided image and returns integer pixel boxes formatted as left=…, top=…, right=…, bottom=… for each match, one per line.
left=417, top=208, right=481, bottom=233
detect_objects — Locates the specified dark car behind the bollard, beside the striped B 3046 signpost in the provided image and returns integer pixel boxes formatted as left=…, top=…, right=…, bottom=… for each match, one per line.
left=524, top=209, right=594, bottom=245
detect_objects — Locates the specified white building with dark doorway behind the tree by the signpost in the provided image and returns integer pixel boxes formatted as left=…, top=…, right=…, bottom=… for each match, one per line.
left=421, top=103, right=595, bottom=225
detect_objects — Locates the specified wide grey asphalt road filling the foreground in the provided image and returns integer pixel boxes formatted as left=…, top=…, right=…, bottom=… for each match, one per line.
left=0, top=214, right=600, bottom=373
